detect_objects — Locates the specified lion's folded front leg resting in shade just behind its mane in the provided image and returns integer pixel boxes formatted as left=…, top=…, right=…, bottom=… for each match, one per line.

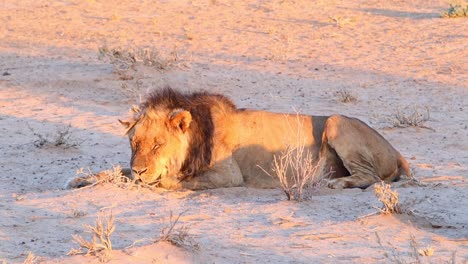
left=181, top=156, right=244, bottom=190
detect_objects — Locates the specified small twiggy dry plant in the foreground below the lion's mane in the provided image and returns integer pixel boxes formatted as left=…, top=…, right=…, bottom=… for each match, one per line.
left=156, top=211, right=199, bottom=250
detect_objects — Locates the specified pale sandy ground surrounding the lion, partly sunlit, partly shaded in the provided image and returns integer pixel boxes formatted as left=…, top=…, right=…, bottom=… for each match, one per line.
left=0, top=0, right=468, bottom=263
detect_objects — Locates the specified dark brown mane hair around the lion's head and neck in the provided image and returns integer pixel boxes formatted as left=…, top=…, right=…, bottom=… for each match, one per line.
left=142, top=87, right=236, bottom=180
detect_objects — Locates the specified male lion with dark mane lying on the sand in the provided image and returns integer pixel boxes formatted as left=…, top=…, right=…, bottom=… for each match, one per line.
left=115, top=88, right=411, bottom=189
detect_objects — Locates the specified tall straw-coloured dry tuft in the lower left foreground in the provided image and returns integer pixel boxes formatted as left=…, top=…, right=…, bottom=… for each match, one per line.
left=68, top=212, right=115, bottom=262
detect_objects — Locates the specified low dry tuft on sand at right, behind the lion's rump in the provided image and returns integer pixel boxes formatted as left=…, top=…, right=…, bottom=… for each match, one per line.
left=390, top=106, right=431, bottom=129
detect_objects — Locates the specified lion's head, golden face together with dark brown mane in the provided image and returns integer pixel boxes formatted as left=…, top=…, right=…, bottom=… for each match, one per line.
left=120, top=88, right=235, bottom=188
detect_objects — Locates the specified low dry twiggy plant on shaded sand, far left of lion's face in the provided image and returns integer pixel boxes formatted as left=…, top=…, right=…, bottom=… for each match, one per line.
left=28, top=124, right=83, bottom=149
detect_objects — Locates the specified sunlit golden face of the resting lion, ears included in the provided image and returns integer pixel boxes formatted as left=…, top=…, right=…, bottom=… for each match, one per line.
left=121, top=109, right=192, bottom=184
